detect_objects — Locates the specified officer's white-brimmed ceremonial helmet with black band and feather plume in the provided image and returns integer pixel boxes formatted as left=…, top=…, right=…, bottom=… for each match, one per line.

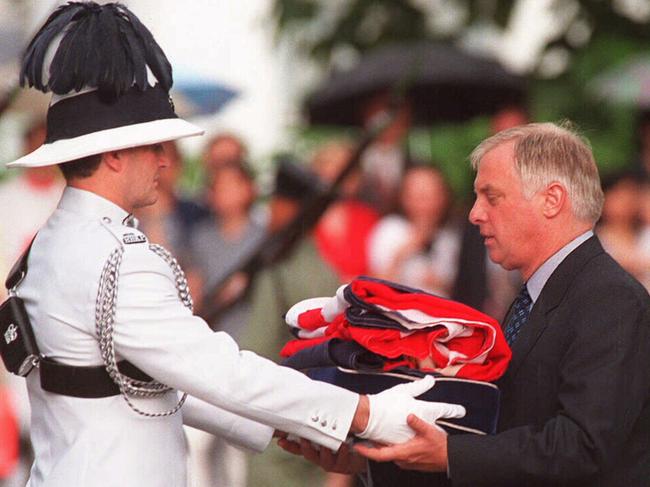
left=7, top=2, right=203, bottom=167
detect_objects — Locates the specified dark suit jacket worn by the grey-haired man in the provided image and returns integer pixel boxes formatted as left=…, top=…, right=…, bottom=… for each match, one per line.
left=448, top=237, right=650, bottom=487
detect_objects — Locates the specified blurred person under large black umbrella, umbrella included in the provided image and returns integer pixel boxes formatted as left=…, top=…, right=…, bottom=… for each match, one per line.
left=306, top=41, right=525, bottom=219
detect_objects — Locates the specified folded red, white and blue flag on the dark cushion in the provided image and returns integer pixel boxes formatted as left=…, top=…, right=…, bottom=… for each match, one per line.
left=281, top=276, right=511, bottom=381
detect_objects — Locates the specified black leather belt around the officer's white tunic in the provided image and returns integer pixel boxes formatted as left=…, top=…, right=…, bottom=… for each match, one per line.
left=38, top=358, right=153, bottom=399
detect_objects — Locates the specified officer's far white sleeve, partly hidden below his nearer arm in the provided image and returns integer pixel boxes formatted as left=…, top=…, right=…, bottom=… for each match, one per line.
left=181, top=396, right=273, bottom=453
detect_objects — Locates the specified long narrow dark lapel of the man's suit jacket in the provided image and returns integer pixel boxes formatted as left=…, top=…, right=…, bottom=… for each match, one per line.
left=504, top=236, right=604, bottom=377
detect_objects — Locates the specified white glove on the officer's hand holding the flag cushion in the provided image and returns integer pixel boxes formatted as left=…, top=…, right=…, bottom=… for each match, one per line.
left=357, top=375, right=465, bottom=444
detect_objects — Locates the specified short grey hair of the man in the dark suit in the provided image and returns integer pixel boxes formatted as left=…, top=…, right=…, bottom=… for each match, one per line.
left=470, top=122, right=604, bottom=223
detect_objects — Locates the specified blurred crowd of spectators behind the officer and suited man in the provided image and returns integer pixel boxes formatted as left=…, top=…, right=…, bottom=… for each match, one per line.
left=0, top=109, right=650, bottom=487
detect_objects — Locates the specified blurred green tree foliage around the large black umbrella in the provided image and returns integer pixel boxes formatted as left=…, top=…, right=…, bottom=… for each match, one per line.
left=275, top=0, right=650, bottom=197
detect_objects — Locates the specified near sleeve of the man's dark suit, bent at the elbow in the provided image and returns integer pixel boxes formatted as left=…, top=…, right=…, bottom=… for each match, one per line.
left=448, top=279, right=650, bottom=486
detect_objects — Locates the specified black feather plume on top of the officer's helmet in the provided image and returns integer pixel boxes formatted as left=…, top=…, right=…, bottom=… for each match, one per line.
left=20, top=2, right=173, bottom=97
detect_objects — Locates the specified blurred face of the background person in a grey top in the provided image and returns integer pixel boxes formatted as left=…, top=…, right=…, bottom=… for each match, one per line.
left=210, top=164, right=255, bottom=216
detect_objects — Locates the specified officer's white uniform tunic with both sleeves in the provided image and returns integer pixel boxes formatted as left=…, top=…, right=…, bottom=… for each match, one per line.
left=18, top=188, right=358, bottom=487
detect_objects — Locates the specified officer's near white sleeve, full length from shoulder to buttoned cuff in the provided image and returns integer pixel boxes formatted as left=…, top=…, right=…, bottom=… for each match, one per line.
left=109, top=245, right=359, bottom=450
